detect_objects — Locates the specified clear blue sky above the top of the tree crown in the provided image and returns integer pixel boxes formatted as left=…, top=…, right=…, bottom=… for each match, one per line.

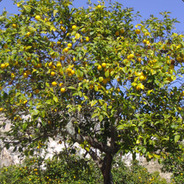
left=0, top=0, right=184, bottom=32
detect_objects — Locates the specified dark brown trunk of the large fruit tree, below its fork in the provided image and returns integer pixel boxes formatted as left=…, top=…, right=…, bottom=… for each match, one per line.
left=101, top=153, right=113, bottom=184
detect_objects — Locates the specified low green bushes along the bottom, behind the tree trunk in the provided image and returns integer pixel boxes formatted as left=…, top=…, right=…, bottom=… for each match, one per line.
left=0, top=156, right=170, bottom=184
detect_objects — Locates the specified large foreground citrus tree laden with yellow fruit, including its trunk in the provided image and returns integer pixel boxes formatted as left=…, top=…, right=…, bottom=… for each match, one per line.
left=0, top=0, right=184, bottom=184
